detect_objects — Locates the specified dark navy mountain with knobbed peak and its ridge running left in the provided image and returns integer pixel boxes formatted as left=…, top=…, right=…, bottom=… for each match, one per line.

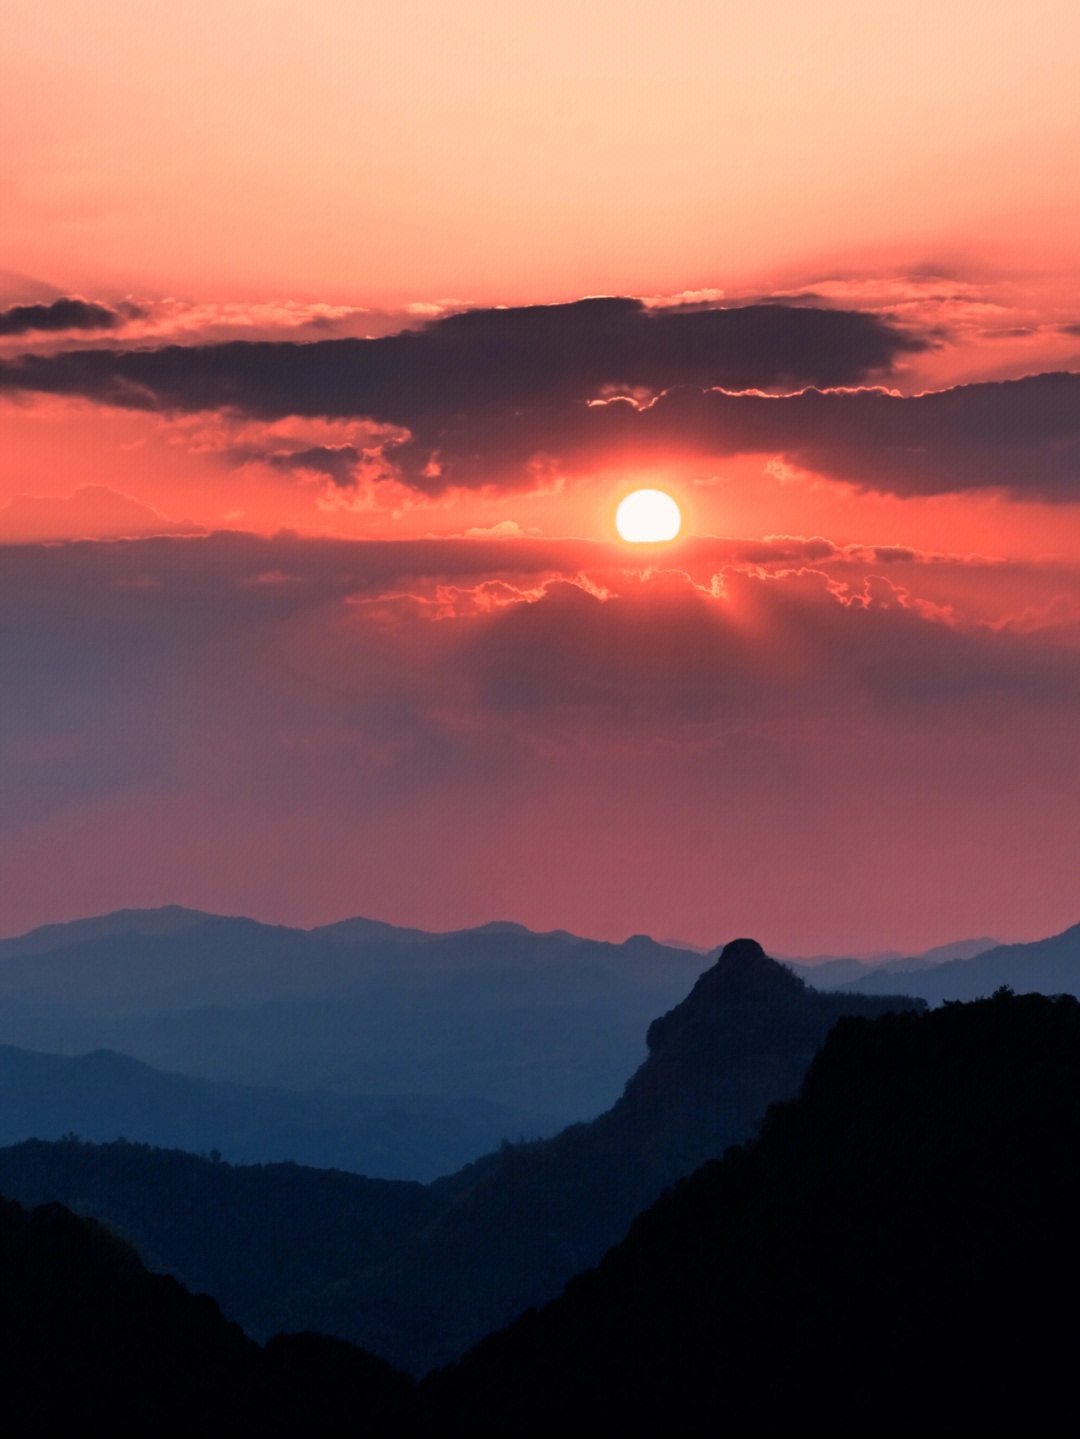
left=0, top=940, right=912, bottom=1373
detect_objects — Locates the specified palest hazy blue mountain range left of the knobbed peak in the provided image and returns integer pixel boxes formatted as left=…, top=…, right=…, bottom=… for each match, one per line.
left=0, top=908, right=705, bottom=1116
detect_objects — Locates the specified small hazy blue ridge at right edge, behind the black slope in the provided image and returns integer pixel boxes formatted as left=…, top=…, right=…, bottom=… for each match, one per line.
left=843, top=924, right=1080, bottom=1004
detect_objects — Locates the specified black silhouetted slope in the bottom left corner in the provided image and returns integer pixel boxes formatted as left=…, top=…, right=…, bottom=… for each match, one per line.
left=0, top=1200, right=416, bottom=1435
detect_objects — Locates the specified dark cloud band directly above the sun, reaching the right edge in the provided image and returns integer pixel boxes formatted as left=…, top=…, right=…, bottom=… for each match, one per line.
left=391, top=373, right=1080, bottom=504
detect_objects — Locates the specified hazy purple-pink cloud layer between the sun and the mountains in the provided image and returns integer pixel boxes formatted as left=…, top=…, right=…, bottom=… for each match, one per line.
left=0, top=534, right=1080, bottom=953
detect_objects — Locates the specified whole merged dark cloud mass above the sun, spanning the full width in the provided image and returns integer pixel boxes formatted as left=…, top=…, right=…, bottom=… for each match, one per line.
left=0, top=299, right=1080, bottom=502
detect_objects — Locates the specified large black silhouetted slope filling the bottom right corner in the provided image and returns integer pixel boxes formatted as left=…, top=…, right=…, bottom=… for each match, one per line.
left=424, top=993, right=1080, bottom=1433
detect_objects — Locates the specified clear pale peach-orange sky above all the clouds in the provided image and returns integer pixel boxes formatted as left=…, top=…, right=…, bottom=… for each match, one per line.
left=0, top=0, right=1080, bottom=307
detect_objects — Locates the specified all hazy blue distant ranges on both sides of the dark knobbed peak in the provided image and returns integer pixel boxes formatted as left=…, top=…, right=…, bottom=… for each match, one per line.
left=8, top=905, right=1080, bottom=1183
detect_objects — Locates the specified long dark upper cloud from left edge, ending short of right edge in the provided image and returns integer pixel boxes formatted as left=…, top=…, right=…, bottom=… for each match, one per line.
left=0, top=298, right=925, bottom=492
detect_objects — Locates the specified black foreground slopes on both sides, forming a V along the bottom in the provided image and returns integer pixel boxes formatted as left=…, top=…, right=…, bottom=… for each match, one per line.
left=8, top=991, right=1080, bottom=1433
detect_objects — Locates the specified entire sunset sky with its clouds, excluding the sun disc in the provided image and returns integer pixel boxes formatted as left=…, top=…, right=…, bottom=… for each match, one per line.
left=0, top=0, right=1080, bottom=954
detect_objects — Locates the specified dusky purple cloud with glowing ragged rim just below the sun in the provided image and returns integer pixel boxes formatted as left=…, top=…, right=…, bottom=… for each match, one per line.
left=467, top=573, right=1080, bottom=740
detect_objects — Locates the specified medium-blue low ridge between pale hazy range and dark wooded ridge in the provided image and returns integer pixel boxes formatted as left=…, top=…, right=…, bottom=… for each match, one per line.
left=0, top=1045, right=558, bottom=1180
